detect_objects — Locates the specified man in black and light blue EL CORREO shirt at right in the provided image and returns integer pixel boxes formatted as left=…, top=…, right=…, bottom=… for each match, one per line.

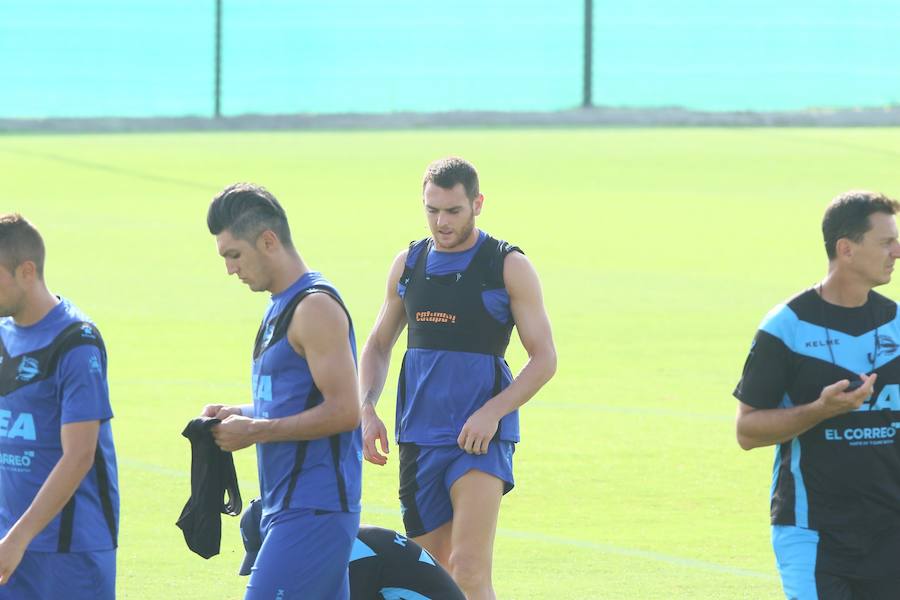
left=734, top=192, right=900, bottom=600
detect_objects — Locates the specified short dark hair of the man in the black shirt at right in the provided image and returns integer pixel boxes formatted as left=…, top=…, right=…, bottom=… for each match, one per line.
left=822, top=190, right=900, bottom=260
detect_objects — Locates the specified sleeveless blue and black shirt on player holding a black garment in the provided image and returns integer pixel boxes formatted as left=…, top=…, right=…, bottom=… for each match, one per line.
left=252, top=272, right=362, bottom=517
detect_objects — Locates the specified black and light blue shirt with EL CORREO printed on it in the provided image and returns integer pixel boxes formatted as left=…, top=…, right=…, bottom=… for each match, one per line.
left=734, top=289, right=900, bottom=533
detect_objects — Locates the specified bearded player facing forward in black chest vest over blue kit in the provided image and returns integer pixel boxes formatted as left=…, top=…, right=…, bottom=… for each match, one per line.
left=360, top=157, right=556, bottom=600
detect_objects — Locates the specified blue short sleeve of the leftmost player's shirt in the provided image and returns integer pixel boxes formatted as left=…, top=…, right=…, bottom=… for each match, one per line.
left=57, top=346, right=113, bottom=425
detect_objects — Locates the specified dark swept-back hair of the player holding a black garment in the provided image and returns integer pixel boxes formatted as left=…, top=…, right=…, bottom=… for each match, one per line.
left=206, top=183, right=294, bottom=248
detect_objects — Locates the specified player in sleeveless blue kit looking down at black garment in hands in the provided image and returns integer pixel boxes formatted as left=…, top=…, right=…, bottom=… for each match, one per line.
left=202, top=183, right=362, bottom=600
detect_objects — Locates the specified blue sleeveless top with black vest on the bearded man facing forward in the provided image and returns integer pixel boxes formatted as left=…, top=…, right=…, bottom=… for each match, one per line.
left=396, top=231, right=519, bottom=446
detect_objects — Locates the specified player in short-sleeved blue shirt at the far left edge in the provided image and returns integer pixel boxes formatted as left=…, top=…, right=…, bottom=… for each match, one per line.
left=0, top=214, right=119, bottom=600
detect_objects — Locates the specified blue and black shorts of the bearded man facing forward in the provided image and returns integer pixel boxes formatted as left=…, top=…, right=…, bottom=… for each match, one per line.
left=399, top=441, right=516, bottom=537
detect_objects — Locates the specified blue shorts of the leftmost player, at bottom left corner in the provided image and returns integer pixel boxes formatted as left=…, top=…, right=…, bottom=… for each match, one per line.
left=0, top=550, right=116, bottom=600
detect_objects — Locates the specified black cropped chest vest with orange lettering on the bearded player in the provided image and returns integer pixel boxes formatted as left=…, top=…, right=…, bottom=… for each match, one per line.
left=400, top=236, right=521, bottom=357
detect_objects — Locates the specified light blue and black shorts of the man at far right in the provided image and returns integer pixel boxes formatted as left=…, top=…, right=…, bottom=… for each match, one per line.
left=772, top=525, right=900, bottom=600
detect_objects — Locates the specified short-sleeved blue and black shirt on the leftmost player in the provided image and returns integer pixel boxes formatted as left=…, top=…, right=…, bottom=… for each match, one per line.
left=0, top=298, right=119, bottom=552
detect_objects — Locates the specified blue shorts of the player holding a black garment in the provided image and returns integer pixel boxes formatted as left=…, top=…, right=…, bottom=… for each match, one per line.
left=244, top=509, right=359, bottom=600
